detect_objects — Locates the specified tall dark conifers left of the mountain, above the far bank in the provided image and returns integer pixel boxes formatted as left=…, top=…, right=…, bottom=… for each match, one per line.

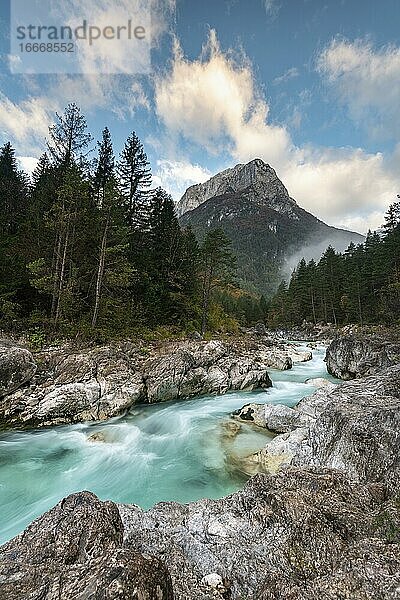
left=0, top=104, right=258, bottom=337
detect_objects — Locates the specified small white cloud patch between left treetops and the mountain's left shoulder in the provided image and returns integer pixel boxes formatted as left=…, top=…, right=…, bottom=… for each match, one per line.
left=153, top=160, right=212, bottom=200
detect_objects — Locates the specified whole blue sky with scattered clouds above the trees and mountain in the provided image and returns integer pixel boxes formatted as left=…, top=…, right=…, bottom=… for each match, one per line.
left=0, top=0, right=400, bottom=232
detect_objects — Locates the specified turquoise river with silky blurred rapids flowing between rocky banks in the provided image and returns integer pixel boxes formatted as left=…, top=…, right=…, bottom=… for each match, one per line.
left=0, top=345, right=338, bottom=543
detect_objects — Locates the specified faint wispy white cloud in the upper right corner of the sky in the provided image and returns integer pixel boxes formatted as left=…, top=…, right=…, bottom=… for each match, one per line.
left=317, top=39, right=400, bottom=138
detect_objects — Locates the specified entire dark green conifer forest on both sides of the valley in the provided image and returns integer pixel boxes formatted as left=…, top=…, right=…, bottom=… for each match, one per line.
left=0, top=104, right=400, bottom=340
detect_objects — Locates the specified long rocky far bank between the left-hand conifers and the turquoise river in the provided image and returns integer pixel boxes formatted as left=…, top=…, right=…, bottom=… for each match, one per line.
left=0, top=337, right=312, bottom=427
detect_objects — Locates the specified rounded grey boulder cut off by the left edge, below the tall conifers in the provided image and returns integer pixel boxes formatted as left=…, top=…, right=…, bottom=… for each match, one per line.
left=0, top=341, right=37, bottom=398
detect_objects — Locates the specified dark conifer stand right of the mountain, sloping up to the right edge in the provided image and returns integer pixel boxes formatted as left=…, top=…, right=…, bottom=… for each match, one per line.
left=267, top=205, right=400, bottom=326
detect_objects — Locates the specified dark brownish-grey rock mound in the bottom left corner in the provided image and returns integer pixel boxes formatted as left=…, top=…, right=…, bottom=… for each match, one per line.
left=0, top=492, right=173, bottom=600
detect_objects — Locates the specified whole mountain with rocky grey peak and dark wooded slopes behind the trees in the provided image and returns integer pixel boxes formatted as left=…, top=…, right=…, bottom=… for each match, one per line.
left=177, top=159, right=364, bottom=296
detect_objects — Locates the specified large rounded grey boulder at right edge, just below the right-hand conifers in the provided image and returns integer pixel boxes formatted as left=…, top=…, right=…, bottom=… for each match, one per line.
left=325, top=334, right=400, bottom=380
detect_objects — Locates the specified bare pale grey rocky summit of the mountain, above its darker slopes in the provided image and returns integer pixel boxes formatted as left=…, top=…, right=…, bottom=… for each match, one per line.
left=177, top=158, right=296, bottom=216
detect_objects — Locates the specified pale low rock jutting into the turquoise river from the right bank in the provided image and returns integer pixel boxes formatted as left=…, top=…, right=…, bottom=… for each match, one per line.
left=234, top=404, right=309, bottom=433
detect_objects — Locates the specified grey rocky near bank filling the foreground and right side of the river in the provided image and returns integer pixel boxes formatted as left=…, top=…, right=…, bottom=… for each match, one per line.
left=0, top=330, right=400, bottom=600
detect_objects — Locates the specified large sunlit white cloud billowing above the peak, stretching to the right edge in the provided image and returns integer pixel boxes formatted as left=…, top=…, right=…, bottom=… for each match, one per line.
left=155, top=32, right=400, bottom=232
